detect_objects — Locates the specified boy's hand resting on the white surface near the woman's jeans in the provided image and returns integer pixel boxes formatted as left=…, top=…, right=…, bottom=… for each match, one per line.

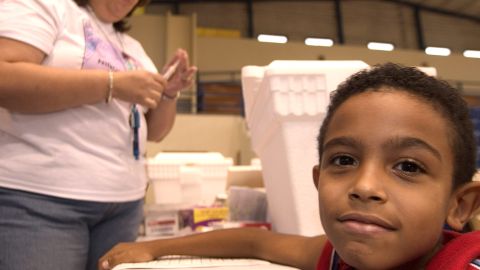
left=98, top=242, right=155, bottom=270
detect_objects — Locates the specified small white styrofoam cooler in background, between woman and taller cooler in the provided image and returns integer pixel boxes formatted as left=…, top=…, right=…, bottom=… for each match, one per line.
left=148, top=152, right=233, bottom=206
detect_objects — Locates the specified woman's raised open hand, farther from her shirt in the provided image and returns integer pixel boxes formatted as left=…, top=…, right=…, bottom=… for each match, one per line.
left=162, top=49, right=197, bottom=97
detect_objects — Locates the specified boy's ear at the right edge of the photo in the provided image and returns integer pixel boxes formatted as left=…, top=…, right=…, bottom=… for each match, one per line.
left=446, top=181, right=480, bottom=231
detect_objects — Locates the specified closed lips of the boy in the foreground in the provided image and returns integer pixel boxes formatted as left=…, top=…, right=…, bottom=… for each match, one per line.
left=338, top=213, right=396, bottom=234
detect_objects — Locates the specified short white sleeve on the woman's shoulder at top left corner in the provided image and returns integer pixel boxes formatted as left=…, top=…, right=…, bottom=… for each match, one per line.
left=0, top=0, right=64, bottom=55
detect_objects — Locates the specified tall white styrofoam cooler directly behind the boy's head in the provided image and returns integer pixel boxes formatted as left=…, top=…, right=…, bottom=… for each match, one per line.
left=242, top=61, right=368, bottom=235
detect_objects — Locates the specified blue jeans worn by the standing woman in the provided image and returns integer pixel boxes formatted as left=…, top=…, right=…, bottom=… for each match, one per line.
left=0, top=188, right=143, bottom=270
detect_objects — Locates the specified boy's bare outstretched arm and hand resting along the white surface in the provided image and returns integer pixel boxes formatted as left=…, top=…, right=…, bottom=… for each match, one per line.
left=99, top=228, right=326, bottom=270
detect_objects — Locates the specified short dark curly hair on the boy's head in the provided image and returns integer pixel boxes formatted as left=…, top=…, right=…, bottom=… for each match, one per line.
left=317, top=63, right=476, bottom=188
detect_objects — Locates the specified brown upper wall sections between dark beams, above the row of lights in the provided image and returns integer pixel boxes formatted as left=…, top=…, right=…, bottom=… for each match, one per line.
left=147, top=0, right=480, bottom=52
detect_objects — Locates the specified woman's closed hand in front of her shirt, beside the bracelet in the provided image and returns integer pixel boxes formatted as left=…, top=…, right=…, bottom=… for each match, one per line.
left=113, top=70, right=167, bottom=109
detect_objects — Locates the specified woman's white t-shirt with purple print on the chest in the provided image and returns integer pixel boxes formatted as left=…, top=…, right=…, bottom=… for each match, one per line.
left=0, top=0, right=156, bottom=202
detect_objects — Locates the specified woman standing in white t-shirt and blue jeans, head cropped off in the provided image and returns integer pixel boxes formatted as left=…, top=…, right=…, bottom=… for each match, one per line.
left=0, top=0, right=196, bottom=270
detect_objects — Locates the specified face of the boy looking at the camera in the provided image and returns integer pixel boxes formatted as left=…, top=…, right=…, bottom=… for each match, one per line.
left=314, top=89, right=453, bottom=269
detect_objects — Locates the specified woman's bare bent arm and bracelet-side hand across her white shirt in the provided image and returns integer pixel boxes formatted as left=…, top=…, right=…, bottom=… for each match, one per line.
left=0, top=38, right=166, bottom=113
